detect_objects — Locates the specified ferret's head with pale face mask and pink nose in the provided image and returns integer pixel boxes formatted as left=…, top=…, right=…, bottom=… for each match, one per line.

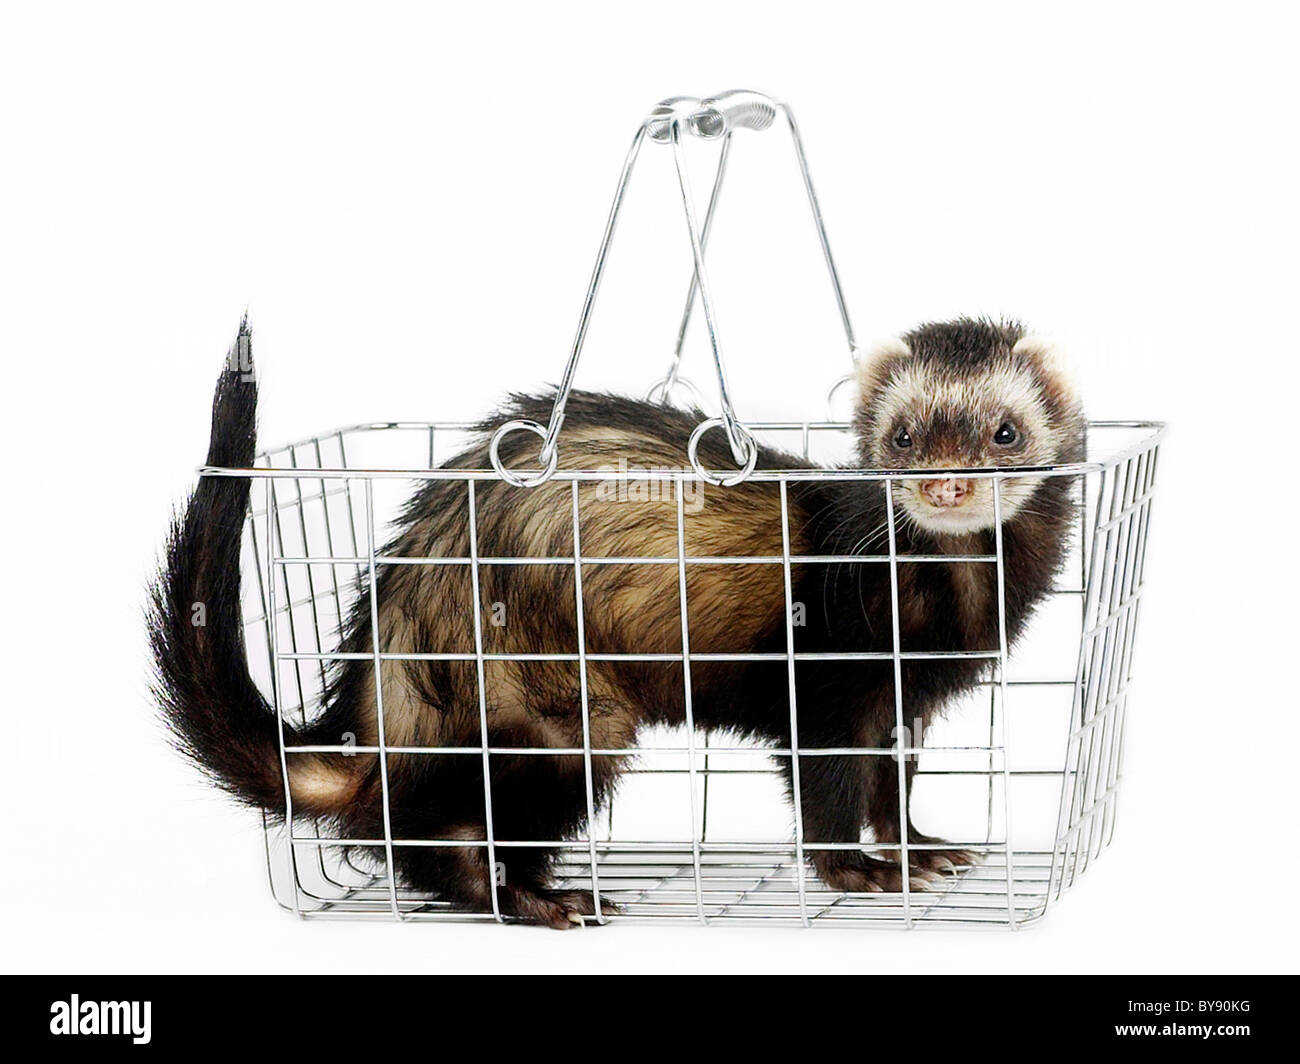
left=854, top=319, right=1084, bottom=535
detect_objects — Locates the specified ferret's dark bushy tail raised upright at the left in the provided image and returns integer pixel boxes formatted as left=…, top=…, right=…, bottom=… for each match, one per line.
left=148, top=319, right=343, bottom=814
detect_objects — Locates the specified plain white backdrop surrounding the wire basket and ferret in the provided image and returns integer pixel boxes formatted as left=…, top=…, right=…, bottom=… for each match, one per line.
left=0, top=0, right=1300, bottom=972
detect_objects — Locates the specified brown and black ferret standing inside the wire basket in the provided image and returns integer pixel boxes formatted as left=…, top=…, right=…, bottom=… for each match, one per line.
left=148, top=319, right=1084, bottom=929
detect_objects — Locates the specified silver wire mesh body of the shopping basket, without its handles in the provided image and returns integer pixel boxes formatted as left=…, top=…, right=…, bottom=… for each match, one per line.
left=218, top=421, right=1162, bottom=927
